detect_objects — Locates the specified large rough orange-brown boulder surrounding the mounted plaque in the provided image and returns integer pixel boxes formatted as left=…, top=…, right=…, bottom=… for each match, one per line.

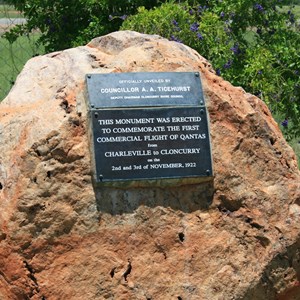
left=0, top=32, right=300, bottom=300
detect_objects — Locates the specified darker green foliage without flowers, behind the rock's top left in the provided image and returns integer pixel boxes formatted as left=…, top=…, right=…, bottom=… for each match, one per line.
left=2, top=0, right=164, bottom=51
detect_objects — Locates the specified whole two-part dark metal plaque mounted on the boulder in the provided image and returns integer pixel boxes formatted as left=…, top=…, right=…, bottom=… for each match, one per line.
left=87, top=73, right=212, bottom=183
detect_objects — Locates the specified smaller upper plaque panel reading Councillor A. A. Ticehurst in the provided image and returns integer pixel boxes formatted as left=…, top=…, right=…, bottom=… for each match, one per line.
left=87, top=72, right=204, bottom=109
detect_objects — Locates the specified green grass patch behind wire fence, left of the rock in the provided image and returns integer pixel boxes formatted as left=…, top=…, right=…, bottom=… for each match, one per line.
left=0, top=34, right=44, bottom=101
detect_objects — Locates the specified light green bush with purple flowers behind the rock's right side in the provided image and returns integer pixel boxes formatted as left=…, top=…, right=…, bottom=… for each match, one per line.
left=122, top=0, right=300, bottom=138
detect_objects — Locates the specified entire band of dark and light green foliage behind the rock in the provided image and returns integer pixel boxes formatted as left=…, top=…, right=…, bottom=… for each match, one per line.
left=5, top=0, right=300, bottom=138
